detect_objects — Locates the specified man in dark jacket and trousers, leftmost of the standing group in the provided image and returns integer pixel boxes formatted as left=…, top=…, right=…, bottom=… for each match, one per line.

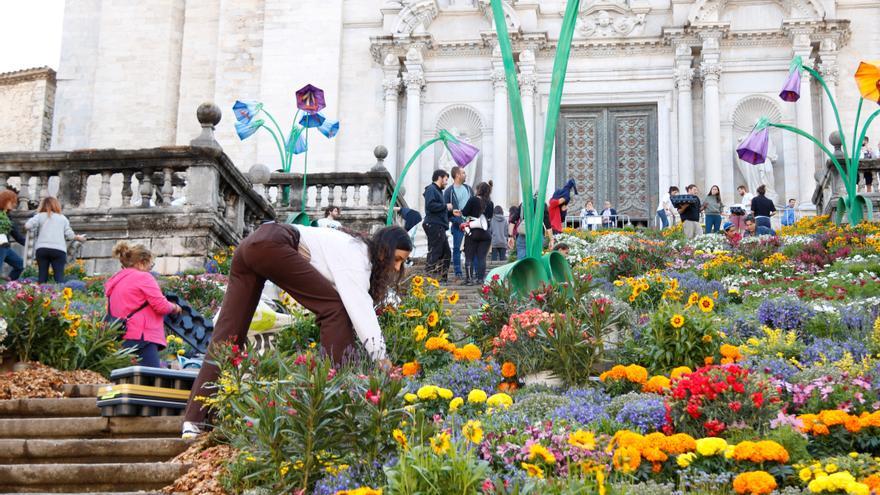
left=422, top=169, right=461, bottom=282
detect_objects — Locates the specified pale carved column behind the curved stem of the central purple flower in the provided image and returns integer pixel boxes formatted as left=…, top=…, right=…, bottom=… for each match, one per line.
left=400, top=48, right=430, bottom=208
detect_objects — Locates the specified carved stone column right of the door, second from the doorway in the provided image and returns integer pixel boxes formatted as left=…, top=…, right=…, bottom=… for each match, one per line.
left=700, top=31, right=722, bottom=193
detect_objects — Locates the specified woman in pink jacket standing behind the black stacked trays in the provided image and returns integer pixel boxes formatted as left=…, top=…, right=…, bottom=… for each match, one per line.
left=104, top=241, right=180, bottom=368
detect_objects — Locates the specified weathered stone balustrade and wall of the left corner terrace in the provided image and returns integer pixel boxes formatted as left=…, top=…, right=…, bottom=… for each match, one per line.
left=0, top=146, right=275, bottom=273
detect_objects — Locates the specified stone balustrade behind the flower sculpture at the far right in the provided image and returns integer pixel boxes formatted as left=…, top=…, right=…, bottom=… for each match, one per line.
left=812, top=131, right=880, bottom=219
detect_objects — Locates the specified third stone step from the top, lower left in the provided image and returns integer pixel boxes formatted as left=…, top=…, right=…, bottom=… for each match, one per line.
left=0, top=438, right=187, bottom=465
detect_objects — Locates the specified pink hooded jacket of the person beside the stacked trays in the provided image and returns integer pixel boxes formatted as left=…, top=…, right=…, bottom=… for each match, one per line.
left=104, top=268, right=174, bottom=348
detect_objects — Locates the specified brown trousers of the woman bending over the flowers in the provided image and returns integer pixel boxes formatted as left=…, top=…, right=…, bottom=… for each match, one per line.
left=184, top=223, right=354, bottom=423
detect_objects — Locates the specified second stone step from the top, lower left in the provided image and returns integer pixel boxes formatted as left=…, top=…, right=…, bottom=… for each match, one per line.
left=0, top=416, right=183, bottom=438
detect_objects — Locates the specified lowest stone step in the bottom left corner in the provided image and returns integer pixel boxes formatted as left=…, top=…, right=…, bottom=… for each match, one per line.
left=0, top=462, right=188, bottom=493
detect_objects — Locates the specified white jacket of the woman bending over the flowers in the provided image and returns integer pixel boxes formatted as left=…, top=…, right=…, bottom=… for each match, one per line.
left=296, top=225, right=385, bottom=360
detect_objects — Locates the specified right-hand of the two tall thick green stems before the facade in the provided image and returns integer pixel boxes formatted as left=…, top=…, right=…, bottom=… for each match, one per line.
left=527, top=0, right=580, bottom=260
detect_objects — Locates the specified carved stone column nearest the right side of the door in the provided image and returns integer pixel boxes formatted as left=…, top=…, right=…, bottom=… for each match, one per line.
left=672, top=43, right=696, bottom=188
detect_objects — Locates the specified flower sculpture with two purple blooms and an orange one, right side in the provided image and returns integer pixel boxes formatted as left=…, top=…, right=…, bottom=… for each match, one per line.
left=736, top=57, right=880, bottom=225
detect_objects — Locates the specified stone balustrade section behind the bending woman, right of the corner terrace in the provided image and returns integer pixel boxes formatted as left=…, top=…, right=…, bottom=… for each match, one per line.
left=251, top=147, right=406, bottom=232
